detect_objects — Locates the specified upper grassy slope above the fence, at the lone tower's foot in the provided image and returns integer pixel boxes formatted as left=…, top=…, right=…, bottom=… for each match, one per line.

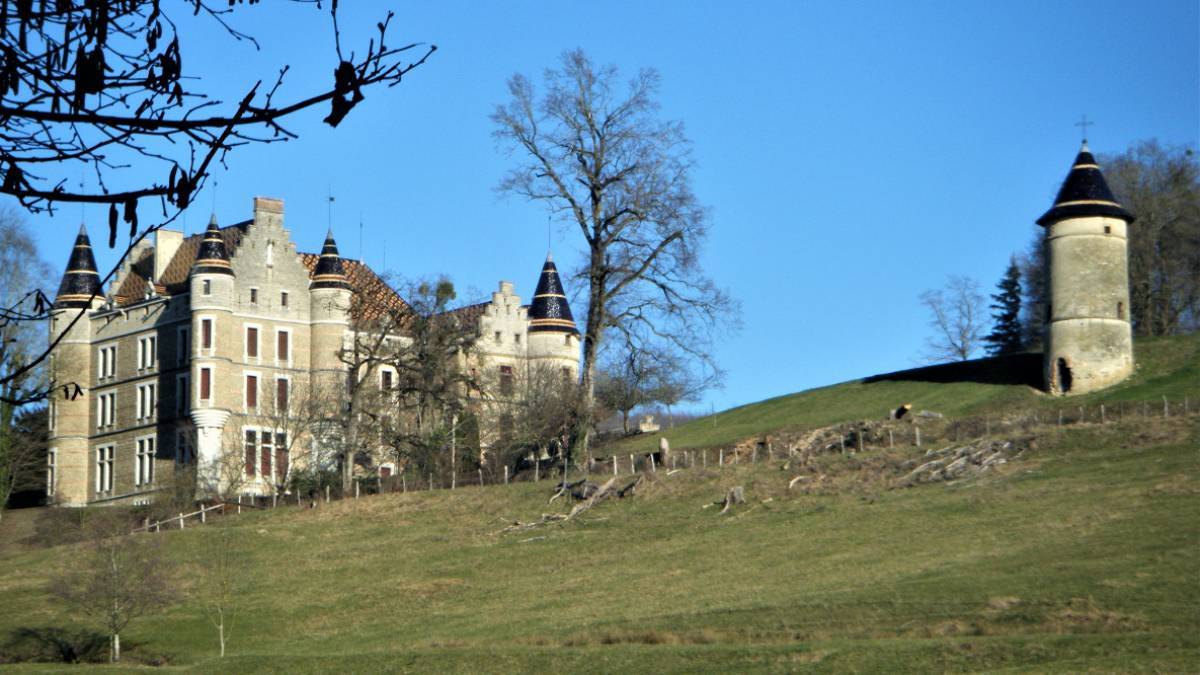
left=614, top=334, right=1200, bottom=454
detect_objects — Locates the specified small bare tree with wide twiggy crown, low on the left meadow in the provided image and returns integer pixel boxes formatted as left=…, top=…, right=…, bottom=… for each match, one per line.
left=50, top=509, right=176, bottom=663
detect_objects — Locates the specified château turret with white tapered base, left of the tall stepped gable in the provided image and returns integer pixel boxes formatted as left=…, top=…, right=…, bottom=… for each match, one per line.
left=188, top=214, right=241, bottom=492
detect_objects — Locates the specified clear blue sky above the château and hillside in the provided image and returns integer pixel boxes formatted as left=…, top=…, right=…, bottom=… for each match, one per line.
left=21, top=0, right=1200, bottom=410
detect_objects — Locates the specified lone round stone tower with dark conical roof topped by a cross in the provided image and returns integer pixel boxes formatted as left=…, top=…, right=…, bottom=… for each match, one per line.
left=1038, top=141, right=1134, bottom=395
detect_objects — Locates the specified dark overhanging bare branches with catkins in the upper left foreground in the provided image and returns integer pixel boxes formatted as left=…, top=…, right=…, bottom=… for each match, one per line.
left=0, top=0, right=436, bottom=405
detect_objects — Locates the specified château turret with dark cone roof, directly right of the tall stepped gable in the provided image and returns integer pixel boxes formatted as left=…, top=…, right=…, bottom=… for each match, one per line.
left=308, top=229, right=352, bottom=388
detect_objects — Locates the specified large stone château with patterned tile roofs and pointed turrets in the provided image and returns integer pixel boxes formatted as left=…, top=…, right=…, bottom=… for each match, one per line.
left=47, top=197, right=580, bottom=506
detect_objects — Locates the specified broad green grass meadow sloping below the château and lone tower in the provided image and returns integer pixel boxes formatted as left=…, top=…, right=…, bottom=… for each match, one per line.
left=0, top=339, right=1200, bottom=673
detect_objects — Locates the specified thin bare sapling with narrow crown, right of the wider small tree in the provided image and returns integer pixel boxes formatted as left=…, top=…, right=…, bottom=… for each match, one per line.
left=196, top=527, right=246, bottom=658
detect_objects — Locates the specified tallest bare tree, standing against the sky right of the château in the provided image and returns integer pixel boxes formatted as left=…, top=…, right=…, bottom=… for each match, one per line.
left=492, top=50, right=737, bottom=454
